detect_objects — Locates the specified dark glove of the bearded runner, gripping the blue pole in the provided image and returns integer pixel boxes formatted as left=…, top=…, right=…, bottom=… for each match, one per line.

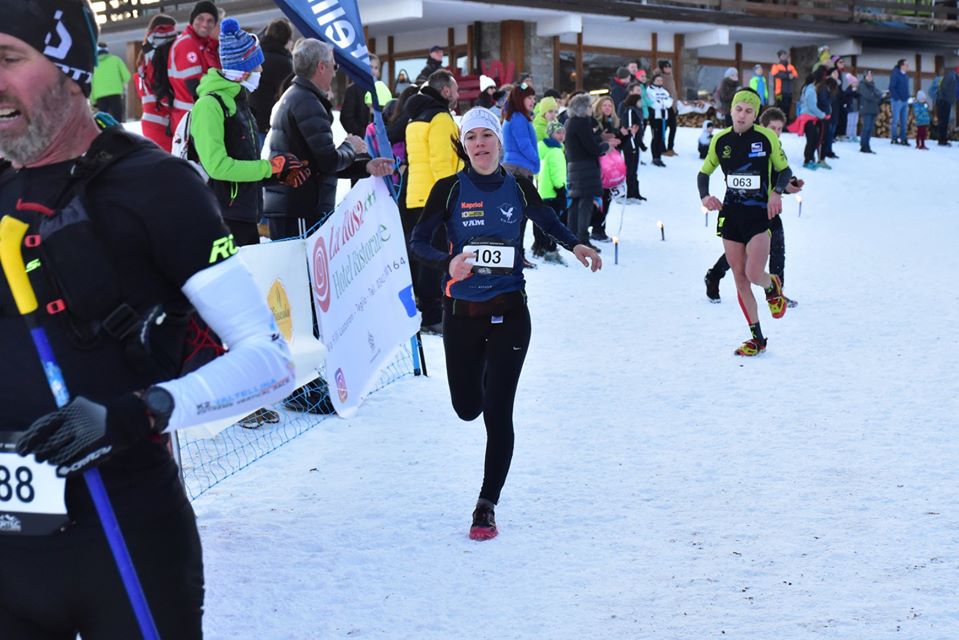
left=17, top=393, right=151, bottom=478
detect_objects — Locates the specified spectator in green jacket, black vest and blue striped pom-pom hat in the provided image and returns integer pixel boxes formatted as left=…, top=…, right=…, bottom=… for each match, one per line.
left=189, top=18, right=310, bottom=246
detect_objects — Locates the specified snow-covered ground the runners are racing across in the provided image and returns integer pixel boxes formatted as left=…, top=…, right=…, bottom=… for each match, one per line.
left=189, top=130, right=959, bottom=640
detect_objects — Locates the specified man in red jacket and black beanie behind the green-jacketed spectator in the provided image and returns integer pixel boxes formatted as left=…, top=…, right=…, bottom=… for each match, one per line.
left=167, top=0, right=220, bottom=131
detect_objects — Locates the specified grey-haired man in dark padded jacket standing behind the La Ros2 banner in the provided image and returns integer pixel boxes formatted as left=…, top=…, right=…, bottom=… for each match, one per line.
left=264, top=38, right=393, bottom=240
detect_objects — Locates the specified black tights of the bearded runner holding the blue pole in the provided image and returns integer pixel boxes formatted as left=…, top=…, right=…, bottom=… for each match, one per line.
left=0, top=505, right=203, bottom=640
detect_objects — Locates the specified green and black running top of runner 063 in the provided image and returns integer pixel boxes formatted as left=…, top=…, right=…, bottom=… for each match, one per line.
left=698, top=125, right=792, bottom=208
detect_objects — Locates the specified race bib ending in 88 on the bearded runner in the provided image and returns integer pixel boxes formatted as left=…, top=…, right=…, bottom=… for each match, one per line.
left=0, top=431, right=70, bottom=536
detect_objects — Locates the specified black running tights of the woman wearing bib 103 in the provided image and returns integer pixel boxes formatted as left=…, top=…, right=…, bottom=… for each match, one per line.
left=443, top=298, right=530, bottom=504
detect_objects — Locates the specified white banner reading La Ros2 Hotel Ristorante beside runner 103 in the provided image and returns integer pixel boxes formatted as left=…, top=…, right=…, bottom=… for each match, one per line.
left=306, top=178, right=420, bottom=418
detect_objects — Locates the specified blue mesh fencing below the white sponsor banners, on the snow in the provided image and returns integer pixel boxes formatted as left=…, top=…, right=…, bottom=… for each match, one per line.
left=177, top=343, right=413, bottom=500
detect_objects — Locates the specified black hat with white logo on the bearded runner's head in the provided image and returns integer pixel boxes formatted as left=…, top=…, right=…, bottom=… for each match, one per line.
left=0, top=0, right=100, bottom=96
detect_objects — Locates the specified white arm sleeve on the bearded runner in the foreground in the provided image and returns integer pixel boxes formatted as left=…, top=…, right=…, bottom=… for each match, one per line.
left=158, top=257, right=295, bottom=431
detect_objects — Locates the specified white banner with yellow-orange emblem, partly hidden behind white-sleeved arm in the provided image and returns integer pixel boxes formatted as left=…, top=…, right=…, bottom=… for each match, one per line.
left=188, top=240, right=326, bottom=438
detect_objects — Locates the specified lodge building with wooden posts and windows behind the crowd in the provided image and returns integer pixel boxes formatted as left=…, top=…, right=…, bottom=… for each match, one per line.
left=93, top=0, right=959, bottom=116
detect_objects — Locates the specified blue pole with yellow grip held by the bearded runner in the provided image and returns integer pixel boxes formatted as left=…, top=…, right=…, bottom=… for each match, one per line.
left=0, top=216, right=160, bottom=640
